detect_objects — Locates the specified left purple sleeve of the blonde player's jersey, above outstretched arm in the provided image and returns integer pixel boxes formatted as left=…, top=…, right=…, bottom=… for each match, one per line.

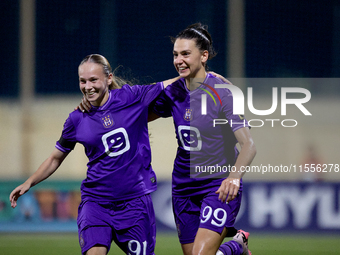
left=55, top=114, right=77, bottom=152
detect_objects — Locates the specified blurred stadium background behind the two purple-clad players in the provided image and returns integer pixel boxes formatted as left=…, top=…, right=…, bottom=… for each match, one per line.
left=0, top=0, right=340, bottom=254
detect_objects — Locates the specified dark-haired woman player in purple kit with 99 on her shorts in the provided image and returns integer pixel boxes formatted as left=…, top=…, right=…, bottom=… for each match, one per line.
left=154, top=23, right=256, bottom=255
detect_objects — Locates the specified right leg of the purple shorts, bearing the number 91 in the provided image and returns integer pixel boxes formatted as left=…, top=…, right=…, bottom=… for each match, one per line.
left=113, top=195, right=156, bottom=255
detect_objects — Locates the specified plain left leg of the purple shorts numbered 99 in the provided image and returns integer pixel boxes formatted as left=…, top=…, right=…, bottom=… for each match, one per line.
left=172, top=196, right=203, bottom=245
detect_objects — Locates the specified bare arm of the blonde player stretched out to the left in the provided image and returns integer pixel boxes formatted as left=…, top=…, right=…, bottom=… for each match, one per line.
left=9, top=148, right=68, bottom=208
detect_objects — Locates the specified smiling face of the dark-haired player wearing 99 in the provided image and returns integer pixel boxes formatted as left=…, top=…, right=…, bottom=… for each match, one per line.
left=173, top=39, right=209, bottom=84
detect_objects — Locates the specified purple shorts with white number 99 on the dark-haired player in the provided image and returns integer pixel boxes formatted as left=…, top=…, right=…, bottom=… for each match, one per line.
left=172, top=187, right=242, bottom=244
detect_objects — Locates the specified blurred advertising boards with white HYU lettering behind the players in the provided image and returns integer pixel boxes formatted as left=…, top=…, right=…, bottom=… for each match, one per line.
left=0, top=181, right=340, bottom=234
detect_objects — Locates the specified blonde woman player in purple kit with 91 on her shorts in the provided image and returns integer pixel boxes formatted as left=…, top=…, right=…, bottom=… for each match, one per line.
left=9, top=54, right=176, bottom=255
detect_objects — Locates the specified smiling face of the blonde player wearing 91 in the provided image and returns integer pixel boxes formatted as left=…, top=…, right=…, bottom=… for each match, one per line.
left=78, top=62, right=112, bottom=106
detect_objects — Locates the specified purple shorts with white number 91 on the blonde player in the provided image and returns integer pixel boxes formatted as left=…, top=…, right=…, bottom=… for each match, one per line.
left=77, top=194, right=156, bottom=255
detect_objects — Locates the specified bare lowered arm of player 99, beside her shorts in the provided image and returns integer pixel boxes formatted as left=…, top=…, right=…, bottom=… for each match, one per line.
left=216, top=127, right=256, bottom=202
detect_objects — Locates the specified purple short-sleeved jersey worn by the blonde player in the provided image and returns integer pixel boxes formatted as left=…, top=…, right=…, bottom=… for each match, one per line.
left=56, top=83, right=163, bottom=201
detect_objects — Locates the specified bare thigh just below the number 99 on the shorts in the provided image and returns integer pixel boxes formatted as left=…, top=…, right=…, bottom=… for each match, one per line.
left=192, top=228, right=227, bottom=255
